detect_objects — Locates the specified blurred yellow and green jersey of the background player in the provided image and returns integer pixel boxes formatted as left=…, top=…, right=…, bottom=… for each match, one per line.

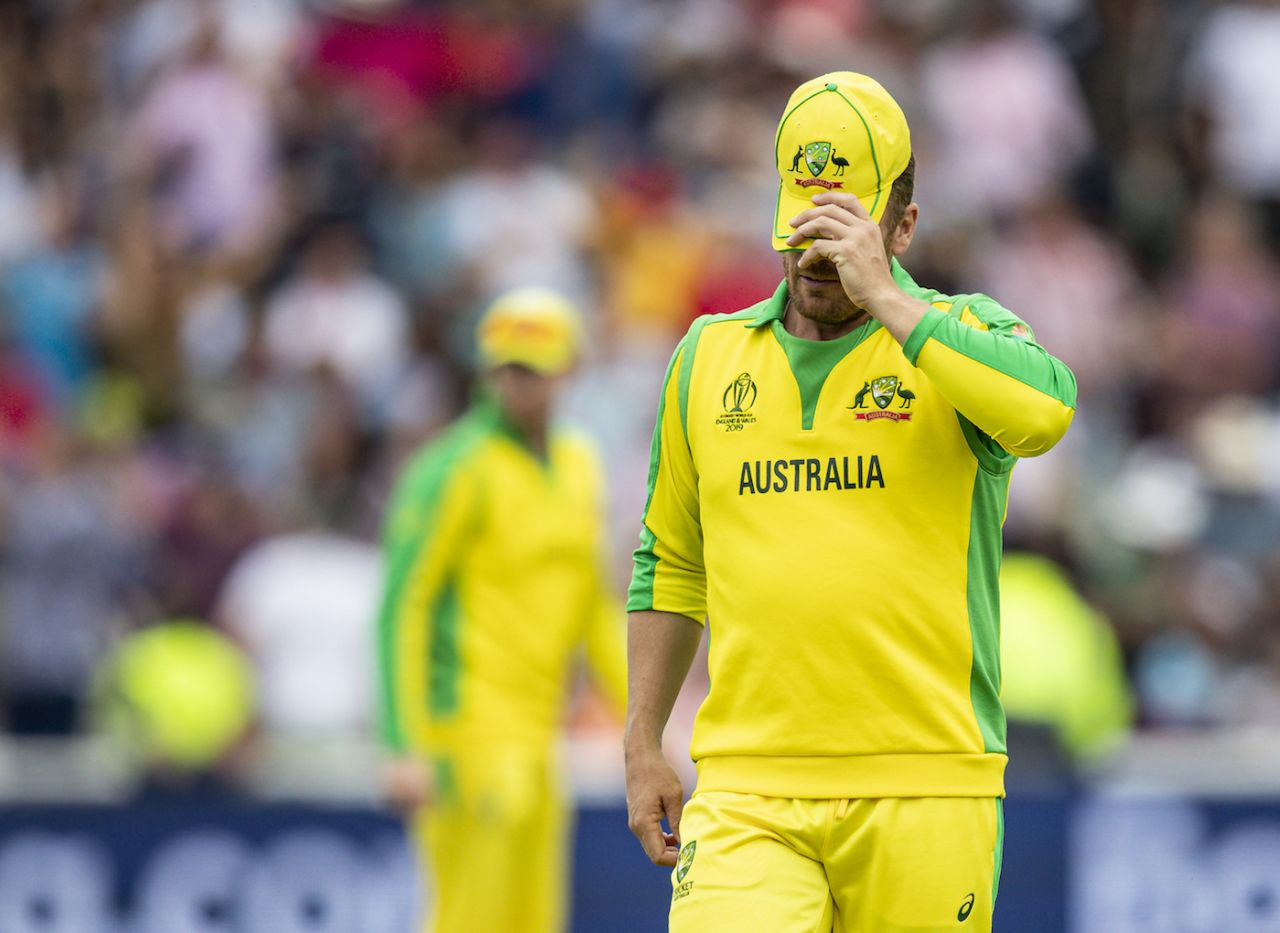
left=379, top=403, right=626, bottom=753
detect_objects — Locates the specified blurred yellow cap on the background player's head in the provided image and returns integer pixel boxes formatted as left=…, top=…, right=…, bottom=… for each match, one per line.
left=477, top=288, right=582, bottom=376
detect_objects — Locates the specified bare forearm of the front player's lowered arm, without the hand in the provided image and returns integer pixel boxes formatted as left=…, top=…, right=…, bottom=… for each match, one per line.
left=625, top=610, right=703, bottom=753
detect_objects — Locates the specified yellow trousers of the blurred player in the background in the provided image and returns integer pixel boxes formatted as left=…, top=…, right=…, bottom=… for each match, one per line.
left=415, top=749, right=570, bottom=933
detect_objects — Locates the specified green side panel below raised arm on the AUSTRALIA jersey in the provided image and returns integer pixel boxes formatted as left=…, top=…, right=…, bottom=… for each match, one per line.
left=966, top=468, right=1009, bottom=754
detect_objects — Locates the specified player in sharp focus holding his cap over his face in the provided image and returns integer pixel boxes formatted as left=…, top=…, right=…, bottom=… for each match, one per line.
left=626, top=72, right=1075, bottom=933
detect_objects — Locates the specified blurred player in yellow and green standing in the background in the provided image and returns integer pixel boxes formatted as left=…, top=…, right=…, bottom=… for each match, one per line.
left=379, top=289, right=626, bottom=933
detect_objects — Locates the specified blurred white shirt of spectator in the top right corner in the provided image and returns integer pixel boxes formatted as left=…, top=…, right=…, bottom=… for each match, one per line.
left=1188, top=4, right=1280, bottom=197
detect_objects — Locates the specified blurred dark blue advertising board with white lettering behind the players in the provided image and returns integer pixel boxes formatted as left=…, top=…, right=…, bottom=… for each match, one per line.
left=0, top=795, right=1280, bottom=933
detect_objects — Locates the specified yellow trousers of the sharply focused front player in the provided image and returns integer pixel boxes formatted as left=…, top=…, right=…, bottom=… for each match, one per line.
left=671, top=791, right=1004, bottom=933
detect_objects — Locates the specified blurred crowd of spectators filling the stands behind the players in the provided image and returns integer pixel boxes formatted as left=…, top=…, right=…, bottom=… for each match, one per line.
left=0, top=0, right=1280, bottom=778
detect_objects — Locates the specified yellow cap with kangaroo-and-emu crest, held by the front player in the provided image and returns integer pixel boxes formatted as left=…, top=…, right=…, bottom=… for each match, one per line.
left=773, top=72, right=911, bottom=252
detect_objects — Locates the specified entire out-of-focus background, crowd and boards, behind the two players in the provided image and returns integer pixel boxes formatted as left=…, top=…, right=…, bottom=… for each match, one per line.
left=0, top=0, right=1280, bottom=933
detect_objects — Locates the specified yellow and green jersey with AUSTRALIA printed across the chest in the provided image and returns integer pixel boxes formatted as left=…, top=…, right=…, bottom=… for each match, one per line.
left=627, top=261, right=1075, bottom=929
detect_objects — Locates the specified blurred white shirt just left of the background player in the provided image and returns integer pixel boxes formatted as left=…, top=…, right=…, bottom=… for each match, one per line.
left=218, top=532, right=381, bottom=735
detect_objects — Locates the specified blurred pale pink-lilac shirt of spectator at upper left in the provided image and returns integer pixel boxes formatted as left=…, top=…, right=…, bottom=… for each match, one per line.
left=136, top=61, right=276, bottom=251
